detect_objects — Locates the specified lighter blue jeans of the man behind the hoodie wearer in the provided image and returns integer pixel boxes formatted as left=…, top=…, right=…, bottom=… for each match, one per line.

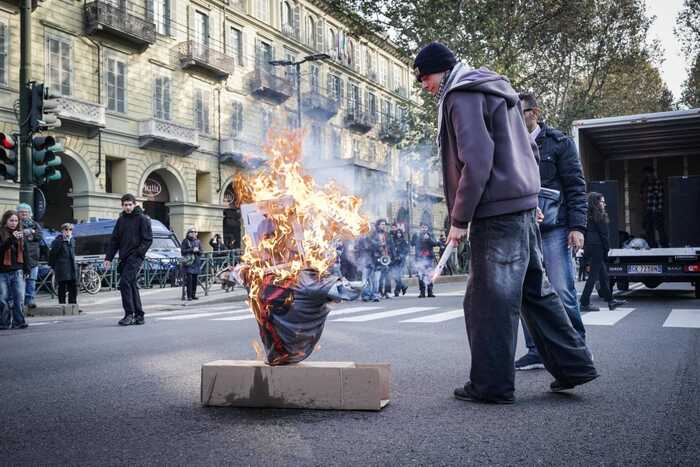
left=523, top=227, right=586, bottom=355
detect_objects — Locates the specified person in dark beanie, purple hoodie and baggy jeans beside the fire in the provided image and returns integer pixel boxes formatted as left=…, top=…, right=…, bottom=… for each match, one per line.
left=413, top=42, right=598, bottom=404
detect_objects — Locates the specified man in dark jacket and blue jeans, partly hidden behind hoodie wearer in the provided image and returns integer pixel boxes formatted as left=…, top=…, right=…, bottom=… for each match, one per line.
left=515, top=93, right=588, bottom=370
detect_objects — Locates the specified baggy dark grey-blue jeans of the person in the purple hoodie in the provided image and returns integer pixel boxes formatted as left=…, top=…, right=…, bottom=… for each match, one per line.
left=464, top=210, right=597, bottom=399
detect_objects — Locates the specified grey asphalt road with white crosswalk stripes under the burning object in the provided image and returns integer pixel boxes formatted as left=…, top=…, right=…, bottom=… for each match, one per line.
left=0, top=284, right=700, bottom=466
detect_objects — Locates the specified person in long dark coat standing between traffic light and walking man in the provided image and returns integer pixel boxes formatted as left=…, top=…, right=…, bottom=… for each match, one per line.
left=49, top=223, right=78, bottom=303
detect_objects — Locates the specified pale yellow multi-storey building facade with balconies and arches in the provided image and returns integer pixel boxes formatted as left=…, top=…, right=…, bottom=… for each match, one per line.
left=0, top=0, right=444, bottom=249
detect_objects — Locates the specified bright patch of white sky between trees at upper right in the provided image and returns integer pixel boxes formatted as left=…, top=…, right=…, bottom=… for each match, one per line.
left=646, top=0, right=689, bottom=100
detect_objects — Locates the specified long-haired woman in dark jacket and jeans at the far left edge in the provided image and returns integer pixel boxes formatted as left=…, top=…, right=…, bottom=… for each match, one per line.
left=0, top=211, right=30, bottom=329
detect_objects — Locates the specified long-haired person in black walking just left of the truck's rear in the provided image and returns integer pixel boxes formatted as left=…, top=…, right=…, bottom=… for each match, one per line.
left=581, top=192, right=625, bottom=311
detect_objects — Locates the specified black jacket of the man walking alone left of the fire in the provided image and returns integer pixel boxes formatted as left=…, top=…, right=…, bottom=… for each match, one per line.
left=105, top=206, right=153, bottom=264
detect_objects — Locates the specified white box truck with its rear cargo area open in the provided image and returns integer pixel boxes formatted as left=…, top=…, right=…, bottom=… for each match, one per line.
left=572, top=109, right=700, bottom=298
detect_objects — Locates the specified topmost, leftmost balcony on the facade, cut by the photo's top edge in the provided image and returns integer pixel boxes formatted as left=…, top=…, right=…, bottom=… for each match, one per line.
left=85, top=0, right=156, bottom=49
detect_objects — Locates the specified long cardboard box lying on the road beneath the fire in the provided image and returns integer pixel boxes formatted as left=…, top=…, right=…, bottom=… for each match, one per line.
left=201, top=360, right=391, bottom=410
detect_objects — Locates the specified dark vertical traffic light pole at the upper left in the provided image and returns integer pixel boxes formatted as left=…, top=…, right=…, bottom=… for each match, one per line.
left=18, top=0, right=34, bottom=206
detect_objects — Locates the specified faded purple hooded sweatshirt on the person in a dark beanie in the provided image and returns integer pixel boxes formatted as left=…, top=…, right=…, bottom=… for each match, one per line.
left=438, top=63, right=540, bottom=228
